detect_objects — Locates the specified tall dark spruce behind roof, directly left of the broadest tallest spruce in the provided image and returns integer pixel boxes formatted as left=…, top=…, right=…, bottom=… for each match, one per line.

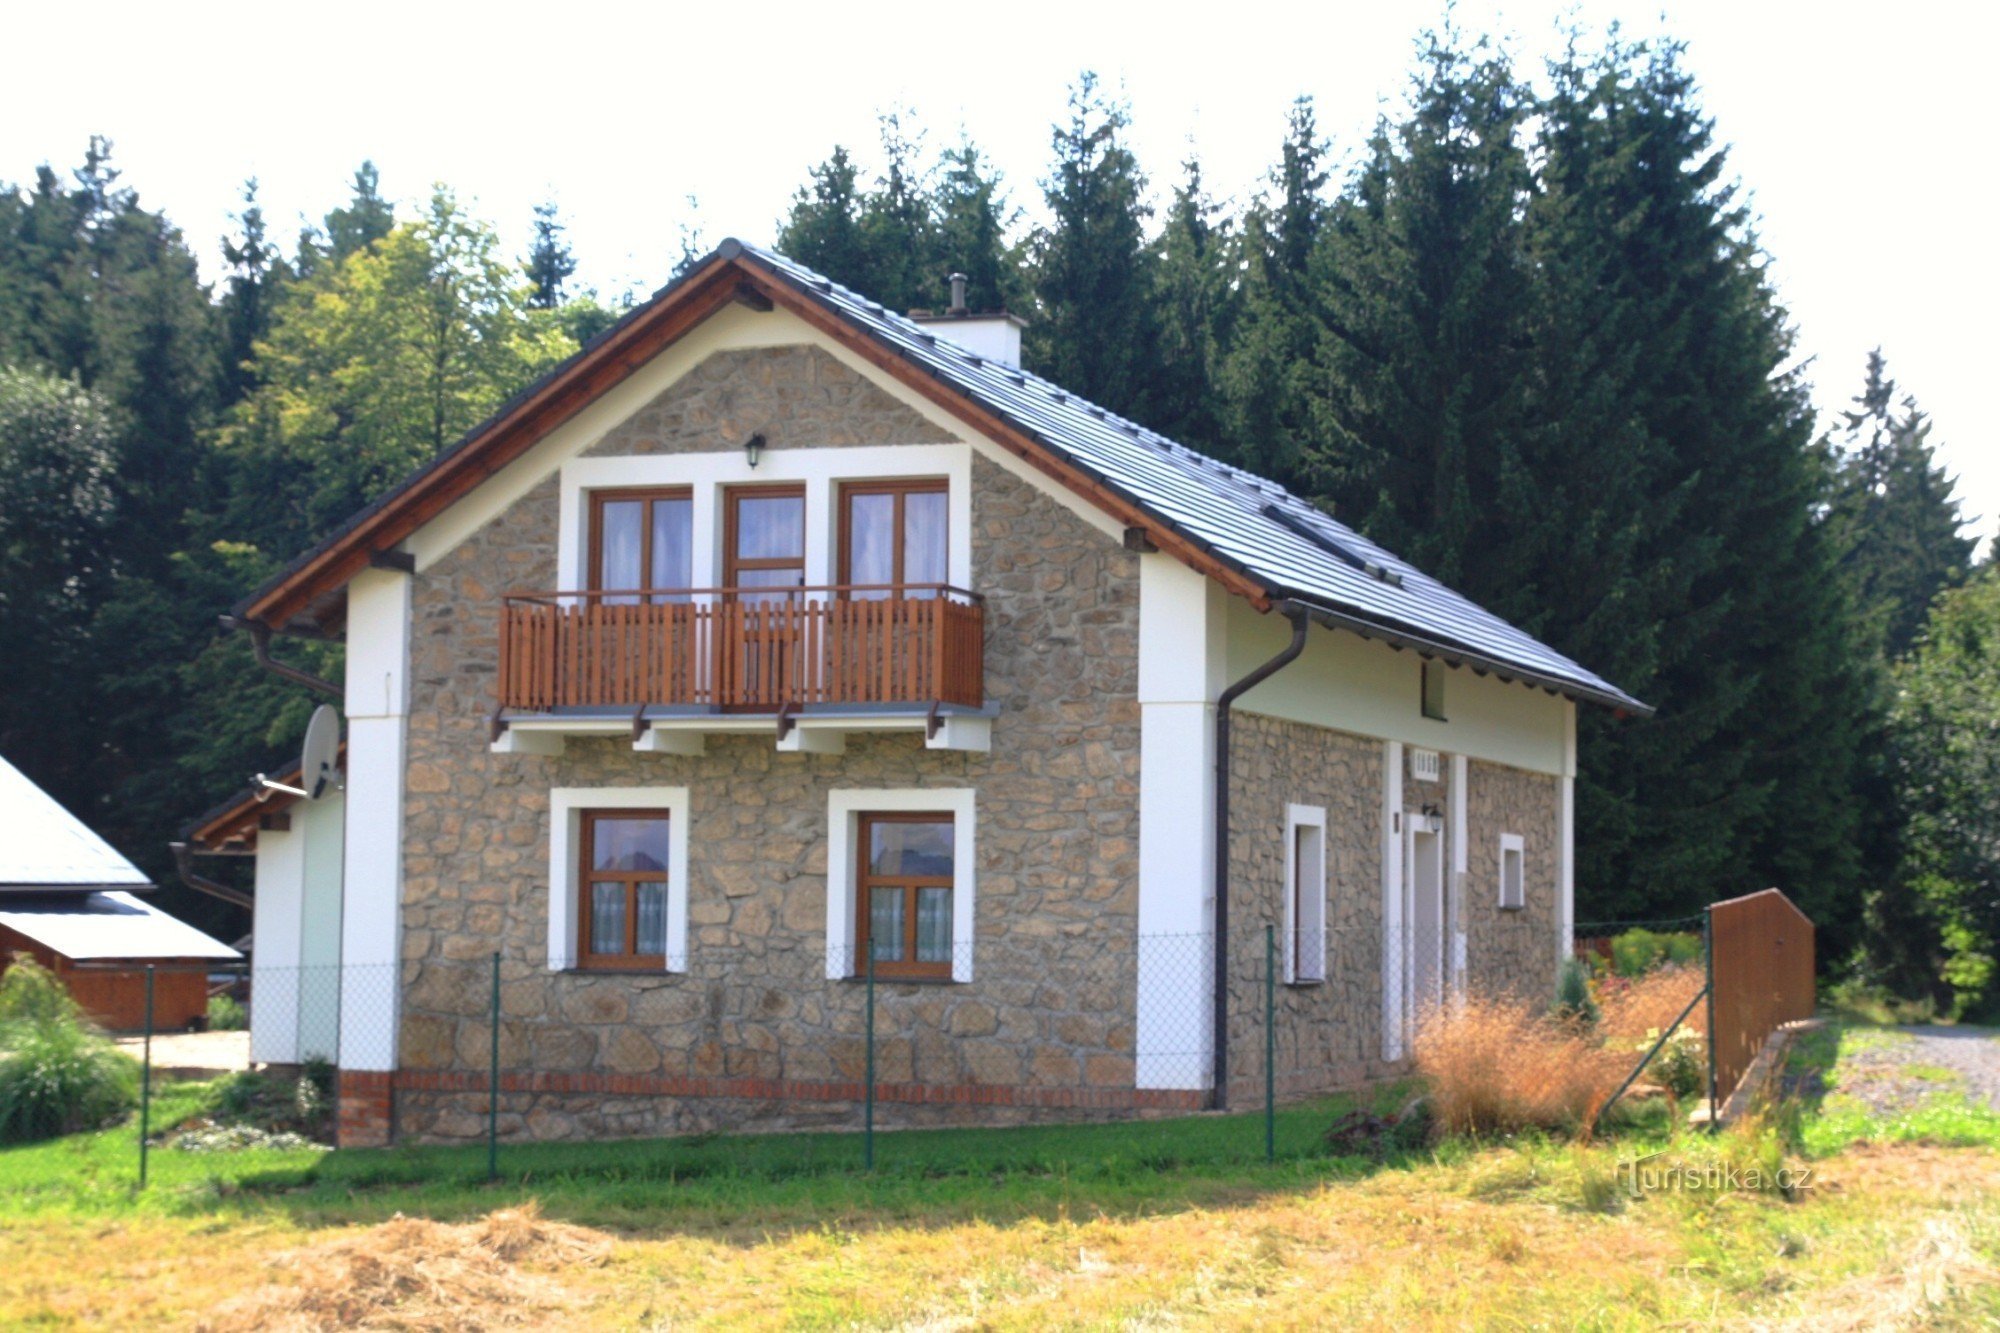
left=1312, top=32, right=1532, bottom=586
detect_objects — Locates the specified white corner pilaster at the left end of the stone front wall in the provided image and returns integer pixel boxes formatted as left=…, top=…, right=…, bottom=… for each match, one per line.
left=340, top=568, right=412, bottom=1071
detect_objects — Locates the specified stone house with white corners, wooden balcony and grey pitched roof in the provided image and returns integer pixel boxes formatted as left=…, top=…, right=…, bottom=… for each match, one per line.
left=180, top=240, right=1644, bottom=1143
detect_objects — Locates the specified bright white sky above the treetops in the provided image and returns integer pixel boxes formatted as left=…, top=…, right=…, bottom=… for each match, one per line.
left=0, top=0, right=2000, bottom=548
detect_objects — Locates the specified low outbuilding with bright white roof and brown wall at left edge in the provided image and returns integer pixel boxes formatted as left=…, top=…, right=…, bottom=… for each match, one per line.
left=0, top=759, right=242, bottom=1031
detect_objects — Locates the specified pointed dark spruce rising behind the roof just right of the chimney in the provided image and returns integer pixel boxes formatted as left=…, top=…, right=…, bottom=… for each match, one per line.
left=1028, top=72, right=1158, bottom=420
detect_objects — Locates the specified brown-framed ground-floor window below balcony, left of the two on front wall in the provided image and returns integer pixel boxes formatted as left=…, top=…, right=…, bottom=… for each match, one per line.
left=576, top=811, right=670, bottom=969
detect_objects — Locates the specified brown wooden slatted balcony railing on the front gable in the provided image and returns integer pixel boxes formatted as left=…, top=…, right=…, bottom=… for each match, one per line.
left=500, top=584, right=986, bottom=713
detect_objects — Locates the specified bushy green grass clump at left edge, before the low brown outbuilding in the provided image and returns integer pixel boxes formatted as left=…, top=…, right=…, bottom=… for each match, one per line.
left=0, top=955, right=138, bottom=1143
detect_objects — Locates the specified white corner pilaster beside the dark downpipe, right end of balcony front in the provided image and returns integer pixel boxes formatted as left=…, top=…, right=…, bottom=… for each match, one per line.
left=1136, top=554, right=1228, bottom=1091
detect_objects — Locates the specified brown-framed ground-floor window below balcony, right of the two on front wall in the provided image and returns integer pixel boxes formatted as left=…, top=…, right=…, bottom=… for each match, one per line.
left=854, top=815, right=956, bottom=981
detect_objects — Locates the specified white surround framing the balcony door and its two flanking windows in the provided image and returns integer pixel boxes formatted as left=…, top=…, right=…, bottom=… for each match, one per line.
left=556, top=444, right=972, bottom=592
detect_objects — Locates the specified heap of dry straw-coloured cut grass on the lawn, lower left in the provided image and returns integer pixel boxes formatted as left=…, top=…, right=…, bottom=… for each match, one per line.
left=200, top=1203, right=612, bottom=1333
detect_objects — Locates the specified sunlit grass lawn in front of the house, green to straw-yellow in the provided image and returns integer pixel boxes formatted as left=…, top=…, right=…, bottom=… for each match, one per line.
left=0, top=1031, right=2000, bottom=1329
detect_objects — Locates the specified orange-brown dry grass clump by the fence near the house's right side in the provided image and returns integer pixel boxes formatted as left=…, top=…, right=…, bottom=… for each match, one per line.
left=1412, top=997, right=1636, bottom=1135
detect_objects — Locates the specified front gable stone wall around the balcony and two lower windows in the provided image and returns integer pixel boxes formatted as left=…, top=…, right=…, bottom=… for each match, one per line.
left=396, top=338, right=1138, bottom=1139
